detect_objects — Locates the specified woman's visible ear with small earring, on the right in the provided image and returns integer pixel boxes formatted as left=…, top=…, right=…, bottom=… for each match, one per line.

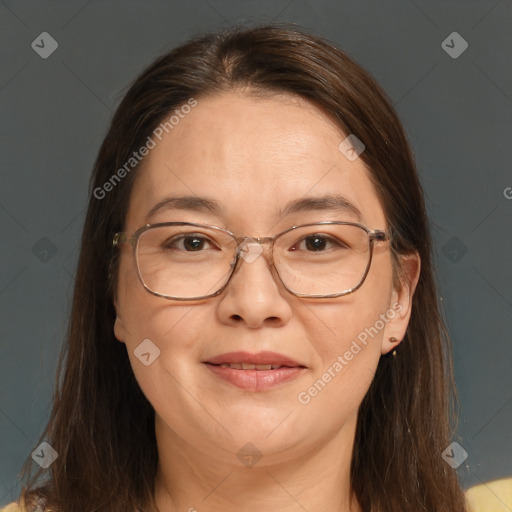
left=382, top=252, right=421, bottom=354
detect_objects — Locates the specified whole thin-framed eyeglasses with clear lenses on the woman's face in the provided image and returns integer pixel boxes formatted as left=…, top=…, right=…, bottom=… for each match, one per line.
left=112, top=221, right=389, bottom=301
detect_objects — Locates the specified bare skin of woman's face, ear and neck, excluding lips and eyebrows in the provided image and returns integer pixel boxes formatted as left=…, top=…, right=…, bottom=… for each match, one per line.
left=114, top=91, right=420, bottom=512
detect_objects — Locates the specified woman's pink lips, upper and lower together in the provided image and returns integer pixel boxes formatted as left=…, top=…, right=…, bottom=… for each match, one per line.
left=204, top=351, right=307, bottom=391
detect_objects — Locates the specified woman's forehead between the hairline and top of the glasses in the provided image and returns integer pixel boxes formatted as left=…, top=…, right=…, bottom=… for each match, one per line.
left=126, top=92, right=385, bottom=234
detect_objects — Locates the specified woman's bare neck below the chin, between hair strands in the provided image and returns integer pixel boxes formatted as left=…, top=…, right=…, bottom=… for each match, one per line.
left=150, top=415, right=362, bottom=512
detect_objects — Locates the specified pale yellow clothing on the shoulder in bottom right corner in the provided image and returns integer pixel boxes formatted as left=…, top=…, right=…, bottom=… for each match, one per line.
left=465, top=478, right=512, bottom=512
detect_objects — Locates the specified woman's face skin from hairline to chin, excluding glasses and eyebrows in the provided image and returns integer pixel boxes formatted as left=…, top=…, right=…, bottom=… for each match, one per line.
left=115, top=92, right=419, bottom=465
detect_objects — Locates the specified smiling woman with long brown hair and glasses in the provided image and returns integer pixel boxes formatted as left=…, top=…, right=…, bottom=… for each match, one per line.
left=8, top=26, right=472, bottom=512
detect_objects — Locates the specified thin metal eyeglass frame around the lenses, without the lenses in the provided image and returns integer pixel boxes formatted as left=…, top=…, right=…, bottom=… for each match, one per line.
left=112, top=221, right=391, bottom=301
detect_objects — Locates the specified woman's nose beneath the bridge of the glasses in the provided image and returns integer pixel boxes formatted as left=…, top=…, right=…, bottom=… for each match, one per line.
left=218, top=239, right=292, bottom=329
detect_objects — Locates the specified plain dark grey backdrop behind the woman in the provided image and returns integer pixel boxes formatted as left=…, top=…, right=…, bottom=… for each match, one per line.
left=0, top=0, right=512, bottom=505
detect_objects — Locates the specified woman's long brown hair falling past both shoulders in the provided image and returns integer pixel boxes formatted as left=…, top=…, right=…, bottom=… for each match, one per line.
left=17, top=25, right=465, bottom=512
